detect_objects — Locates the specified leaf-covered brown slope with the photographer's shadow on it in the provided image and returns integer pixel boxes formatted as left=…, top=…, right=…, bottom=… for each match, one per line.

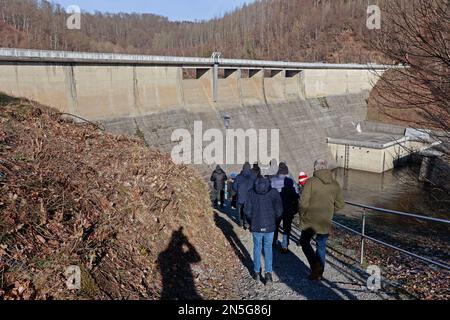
left=0, top=96, right=239, bottom=300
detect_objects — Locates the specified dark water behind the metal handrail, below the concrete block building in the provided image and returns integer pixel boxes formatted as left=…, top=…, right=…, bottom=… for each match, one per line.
left=334, top=165, right=450, bottom=263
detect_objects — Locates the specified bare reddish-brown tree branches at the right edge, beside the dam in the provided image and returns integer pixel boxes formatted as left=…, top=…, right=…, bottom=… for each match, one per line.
left=370, top=0, right=450, bottom=160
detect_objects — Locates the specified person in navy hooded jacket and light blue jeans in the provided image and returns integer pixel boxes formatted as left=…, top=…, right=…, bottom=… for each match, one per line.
left=244, top=177, right=283, bottom=285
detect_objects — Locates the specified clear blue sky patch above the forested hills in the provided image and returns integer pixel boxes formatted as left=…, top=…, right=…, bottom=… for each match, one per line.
left=51, top=0, right=253, bottom=21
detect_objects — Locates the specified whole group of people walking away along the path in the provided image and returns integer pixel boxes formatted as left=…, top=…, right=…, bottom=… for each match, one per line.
left=211, top=160, right=345, bottom=285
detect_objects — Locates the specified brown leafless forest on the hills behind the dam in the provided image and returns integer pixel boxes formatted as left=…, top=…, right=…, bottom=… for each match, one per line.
left=0, top=0, right=385, bottom=63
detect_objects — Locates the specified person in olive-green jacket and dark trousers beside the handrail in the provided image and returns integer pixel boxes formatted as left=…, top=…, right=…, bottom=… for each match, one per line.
left=300, top=160, right=345, bottom=280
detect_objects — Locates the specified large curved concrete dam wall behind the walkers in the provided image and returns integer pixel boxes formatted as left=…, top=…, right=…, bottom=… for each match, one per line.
left=0, top=50, right=385, bottom=175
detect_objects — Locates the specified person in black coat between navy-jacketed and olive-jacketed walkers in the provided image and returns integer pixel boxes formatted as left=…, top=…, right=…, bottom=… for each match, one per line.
left=274, top=178, right=299, bottom=254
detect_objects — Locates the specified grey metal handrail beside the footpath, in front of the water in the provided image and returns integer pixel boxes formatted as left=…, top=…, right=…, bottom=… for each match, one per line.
left=333, top=201, right=450, bottom=270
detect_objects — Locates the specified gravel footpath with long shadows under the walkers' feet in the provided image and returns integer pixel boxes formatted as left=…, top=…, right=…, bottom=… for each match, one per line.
left=216, top=210, right=395, bottom=300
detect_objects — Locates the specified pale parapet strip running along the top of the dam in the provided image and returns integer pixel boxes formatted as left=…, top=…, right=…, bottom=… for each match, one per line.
left=0, top=48, right=402, bottom=70
